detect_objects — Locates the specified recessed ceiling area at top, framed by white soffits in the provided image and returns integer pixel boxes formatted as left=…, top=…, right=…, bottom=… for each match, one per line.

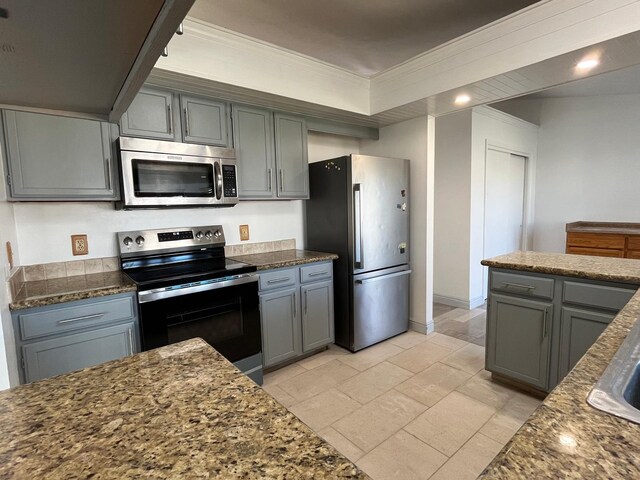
left=189, top=0, right=537, bottom=77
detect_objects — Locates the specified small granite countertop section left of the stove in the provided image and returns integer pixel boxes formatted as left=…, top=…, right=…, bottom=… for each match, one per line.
left=9, top=271, right=136, bottom=310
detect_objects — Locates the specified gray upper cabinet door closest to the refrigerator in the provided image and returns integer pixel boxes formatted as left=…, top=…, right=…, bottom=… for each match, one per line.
left=274, top=113, right=309, bottom=198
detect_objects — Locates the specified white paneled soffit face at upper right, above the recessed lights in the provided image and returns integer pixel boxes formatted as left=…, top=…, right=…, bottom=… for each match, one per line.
left=370, top=0, right=640, bottom=114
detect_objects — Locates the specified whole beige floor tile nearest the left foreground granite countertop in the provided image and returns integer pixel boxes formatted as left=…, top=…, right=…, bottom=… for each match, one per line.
left=289, top=389, right=360, bottom=431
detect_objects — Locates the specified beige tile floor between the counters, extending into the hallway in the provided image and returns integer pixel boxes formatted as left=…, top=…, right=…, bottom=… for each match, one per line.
left=264, top=306, right=540, bottom=480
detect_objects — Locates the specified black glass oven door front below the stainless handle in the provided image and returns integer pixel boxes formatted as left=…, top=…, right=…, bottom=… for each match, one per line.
left=139, top=277, right=262, bottom=362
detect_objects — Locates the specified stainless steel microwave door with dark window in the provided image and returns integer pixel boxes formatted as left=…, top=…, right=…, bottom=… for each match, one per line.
left=120, top=151, right=224, bottom=207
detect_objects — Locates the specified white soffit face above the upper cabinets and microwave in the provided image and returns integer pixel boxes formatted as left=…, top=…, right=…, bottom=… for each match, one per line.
left=156, top=18, right=369, bottom=115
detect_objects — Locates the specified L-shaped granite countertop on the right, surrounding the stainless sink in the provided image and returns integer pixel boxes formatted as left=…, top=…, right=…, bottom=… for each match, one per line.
left=480, top=252, right=640, bottom=479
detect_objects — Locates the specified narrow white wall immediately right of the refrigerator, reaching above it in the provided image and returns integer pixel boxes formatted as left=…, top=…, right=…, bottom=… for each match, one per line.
left=360, top=116, right=433, bottom=332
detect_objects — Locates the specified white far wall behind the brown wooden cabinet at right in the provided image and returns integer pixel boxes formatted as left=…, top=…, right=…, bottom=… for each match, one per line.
left=533, top=95, right=640, bottom=252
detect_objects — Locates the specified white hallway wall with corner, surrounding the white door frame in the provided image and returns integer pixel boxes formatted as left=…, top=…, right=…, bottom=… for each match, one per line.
left=434, top=107, right=538, bottom=308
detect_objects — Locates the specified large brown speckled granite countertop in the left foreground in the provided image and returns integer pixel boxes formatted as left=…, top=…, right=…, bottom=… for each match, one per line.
left=0, top=339, right=368, bottom=479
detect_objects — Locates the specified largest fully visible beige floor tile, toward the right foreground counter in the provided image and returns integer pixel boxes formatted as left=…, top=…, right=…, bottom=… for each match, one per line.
left=405, top=392, right=495, bottom=456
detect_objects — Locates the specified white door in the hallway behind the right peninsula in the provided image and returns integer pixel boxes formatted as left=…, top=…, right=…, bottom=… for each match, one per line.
left=483, top=149, right=526, bottom=299
